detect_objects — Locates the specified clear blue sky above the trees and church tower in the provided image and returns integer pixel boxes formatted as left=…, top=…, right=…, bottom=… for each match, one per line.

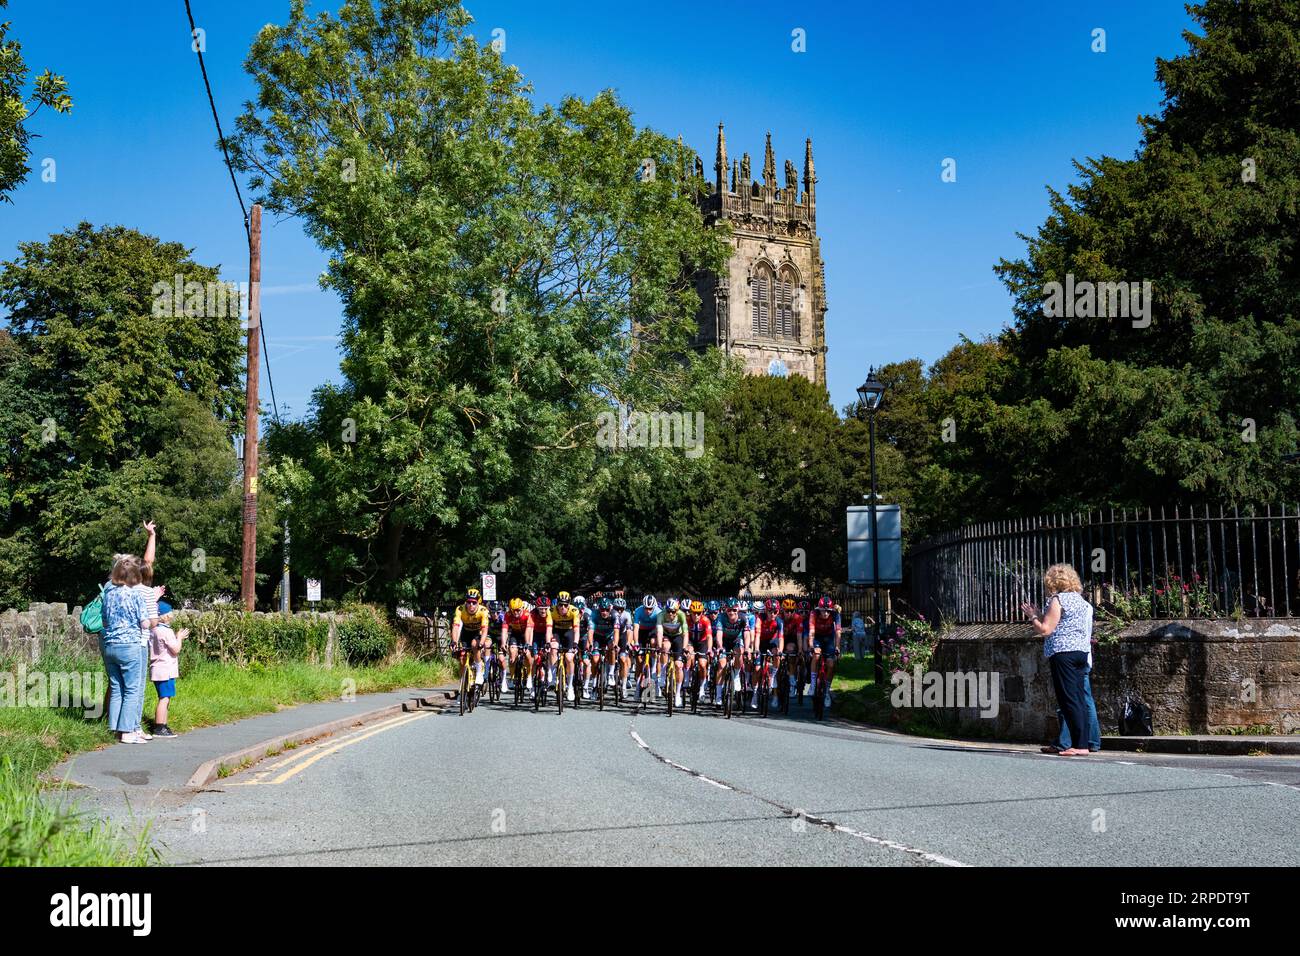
left=0, top=0, right=1191, bottom=415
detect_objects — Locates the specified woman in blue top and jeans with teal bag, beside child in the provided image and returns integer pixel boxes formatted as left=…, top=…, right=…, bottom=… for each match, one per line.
left=99, top=554, right=157, bottom=744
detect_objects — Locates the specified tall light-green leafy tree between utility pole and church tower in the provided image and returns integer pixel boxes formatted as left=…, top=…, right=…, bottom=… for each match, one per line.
left=234, top=0, right=727, bottom=602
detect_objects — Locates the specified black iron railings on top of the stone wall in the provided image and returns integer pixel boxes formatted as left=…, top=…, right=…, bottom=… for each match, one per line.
left=907, top=505, right=1300, bottom=623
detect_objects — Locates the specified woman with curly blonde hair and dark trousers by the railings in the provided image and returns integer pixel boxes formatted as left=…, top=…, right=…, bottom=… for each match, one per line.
left=1021, top=564, right=1092, bottom=757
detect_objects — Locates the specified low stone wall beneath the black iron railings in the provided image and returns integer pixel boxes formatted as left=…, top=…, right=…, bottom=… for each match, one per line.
left=930, top=618, right=1300, bottom=743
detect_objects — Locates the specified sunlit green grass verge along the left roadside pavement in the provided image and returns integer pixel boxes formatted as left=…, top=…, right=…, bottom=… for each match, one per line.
left=0, top=653, right=451, bottom=866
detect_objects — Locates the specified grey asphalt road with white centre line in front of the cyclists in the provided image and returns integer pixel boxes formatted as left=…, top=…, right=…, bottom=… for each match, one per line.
left=111, top=686, right=1300, bottom=866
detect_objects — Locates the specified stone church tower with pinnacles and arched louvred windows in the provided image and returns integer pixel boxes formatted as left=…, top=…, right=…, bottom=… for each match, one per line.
left=696, top=124, right=826, bottom=385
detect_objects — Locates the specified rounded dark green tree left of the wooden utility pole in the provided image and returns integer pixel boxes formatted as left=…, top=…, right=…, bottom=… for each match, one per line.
left=0, top=222, right=257, bottom=604
